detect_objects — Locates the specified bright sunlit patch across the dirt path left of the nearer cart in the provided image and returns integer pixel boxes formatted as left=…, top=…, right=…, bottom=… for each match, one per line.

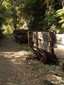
left=0, top=51, right=33, bottom=65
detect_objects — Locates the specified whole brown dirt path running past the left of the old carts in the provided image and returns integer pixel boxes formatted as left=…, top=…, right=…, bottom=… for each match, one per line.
left=0, top=35, right=46, bottom=85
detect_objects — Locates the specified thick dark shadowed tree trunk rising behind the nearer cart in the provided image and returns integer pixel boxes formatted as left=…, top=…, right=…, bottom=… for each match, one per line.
left=33, top=0, right=46, bottom=30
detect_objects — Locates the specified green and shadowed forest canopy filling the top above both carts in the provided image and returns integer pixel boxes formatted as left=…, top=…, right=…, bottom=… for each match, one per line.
left=0, top=0, right=62, bottom=33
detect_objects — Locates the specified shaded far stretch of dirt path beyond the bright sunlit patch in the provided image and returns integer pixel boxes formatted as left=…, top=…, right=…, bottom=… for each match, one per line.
left=0, top=35, right=26, bottom=52
